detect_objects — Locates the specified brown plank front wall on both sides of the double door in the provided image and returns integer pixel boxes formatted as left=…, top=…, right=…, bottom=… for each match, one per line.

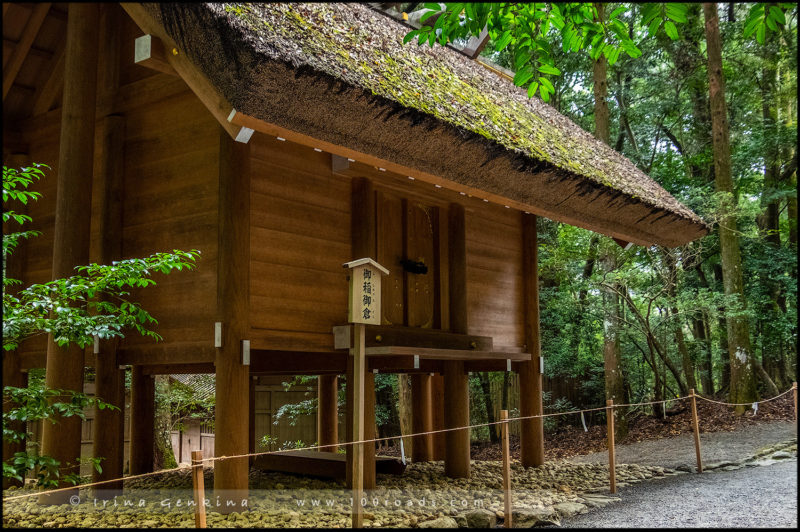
left=250, top=133, right=524, bottom=351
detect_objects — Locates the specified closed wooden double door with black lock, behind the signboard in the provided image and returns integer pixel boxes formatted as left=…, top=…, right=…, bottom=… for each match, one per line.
left=376, top=190, right=441, bottom=329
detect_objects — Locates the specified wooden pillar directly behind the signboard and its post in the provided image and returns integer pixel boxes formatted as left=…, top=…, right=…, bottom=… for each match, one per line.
left=345, top=177, right=377, bottom=489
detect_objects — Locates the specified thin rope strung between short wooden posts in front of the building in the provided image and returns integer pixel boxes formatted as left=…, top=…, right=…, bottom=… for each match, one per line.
left=3, top=387, right=794, bottom=502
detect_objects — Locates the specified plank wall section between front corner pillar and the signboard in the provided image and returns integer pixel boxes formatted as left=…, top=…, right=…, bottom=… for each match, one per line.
left=250, top=134, right=351, bottom=351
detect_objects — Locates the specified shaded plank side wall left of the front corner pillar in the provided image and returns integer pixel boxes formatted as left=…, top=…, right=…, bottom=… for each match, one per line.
left=11, top=13, right=219, bottom=367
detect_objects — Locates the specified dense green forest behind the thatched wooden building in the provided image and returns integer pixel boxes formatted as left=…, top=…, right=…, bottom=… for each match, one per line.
left=281, top=2, right=797, bottom=448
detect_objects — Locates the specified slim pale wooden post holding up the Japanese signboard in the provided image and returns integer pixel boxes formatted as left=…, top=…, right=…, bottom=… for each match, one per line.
left=347, top=323, right=367, bottom=528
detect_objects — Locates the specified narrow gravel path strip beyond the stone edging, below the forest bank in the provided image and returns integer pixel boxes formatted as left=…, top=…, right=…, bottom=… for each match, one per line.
left=569, top=421, right=797, bottom=469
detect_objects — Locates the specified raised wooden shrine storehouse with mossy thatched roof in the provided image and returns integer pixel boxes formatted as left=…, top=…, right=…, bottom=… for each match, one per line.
left=3, top=3, right=708, bottom=508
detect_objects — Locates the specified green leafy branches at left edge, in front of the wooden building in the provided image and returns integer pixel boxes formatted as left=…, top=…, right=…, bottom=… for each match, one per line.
left=3, top=163, right=200, bottom=486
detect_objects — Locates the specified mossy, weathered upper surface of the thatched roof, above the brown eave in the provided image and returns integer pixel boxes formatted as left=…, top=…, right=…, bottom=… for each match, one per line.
left=145, top=3, right=707, bottom=241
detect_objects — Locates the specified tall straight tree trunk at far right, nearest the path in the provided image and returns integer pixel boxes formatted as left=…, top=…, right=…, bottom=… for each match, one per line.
left=703, top=3, right=758, bottom=414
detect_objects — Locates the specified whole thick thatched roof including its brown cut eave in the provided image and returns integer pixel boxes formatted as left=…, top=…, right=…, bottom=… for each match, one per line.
left=146, top=4, right=708, bottom=246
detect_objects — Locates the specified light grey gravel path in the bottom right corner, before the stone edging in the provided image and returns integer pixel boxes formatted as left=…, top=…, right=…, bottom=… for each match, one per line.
left=548, top=458, right=797, bottom=528
